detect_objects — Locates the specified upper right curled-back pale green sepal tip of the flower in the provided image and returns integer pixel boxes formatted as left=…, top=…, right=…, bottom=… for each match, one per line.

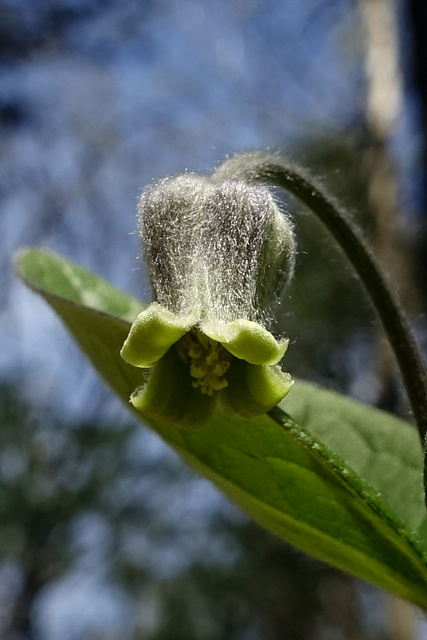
left=201, top=318, right=289, bottom=364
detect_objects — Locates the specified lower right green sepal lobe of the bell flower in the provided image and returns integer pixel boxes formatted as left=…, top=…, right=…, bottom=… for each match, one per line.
left=221, top=358, right=293, bottom=418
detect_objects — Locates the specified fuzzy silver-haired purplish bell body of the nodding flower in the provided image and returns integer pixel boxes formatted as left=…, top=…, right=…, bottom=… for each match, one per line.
left=138, top=174, right=295, bottom=325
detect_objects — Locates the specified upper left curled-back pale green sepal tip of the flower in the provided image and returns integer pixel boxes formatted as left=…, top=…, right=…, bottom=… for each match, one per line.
left=120, top=302, right=192, bottom=367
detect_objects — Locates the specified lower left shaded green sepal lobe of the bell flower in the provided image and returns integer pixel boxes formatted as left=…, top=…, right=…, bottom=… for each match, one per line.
left=130, top=347, right=217, bottom=429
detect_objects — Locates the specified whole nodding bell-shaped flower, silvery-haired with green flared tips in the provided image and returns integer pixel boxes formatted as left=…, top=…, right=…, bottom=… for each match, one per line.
left=121, top=174, right=295, bottom=428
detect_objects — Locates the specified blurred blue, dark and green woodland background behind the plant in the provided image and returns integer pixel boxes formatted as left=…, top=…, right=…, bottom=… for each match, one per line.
left=0, top=0, right=427, bottom=640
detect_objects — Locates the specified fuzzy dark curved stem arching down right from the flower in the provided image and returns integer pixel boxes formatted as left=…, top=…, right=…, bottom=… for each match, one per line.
left=213, top=153, right=427, bottom=444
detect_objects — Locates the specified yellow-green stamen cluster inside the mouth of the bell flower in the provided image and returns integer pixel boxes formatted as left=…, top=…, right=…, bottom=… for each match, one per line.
left=177, top=329, right=231, bottom=396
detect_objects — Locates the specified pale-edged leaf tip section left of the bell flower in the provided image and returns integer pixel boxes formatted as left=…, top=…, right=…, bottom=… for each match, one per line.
left=15, top=249, right=147, bottom=398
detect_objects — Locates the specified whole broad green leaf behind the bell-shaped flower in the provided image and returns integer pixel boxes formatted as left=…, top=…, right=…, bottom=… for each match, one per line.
left=16, top=249, right=427, bottom=610
